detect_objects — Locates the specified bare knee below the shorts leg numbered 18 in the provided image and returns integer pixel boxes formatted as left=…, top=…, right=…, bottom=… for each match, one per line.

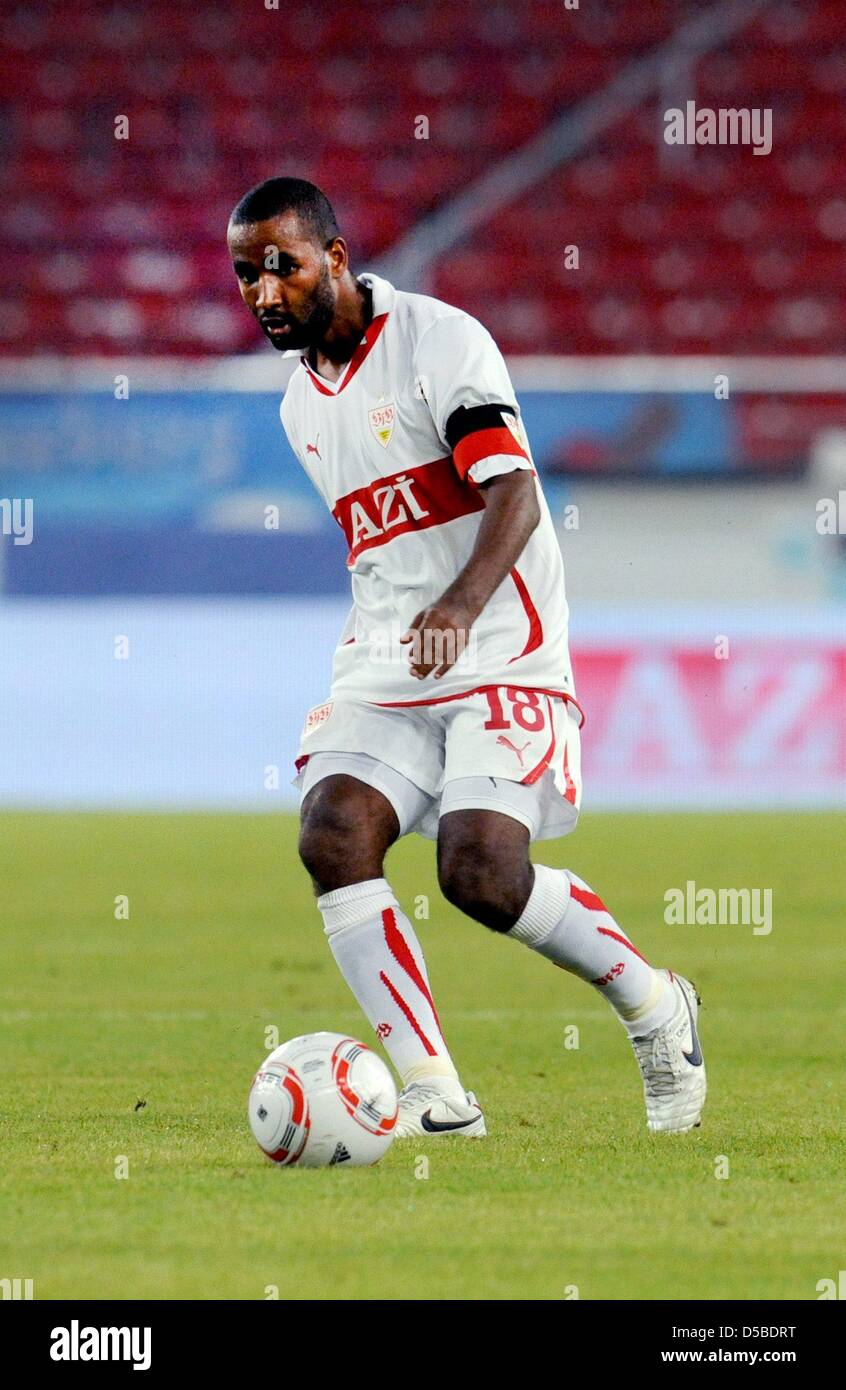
left=438, top=840, right=531, bottom=931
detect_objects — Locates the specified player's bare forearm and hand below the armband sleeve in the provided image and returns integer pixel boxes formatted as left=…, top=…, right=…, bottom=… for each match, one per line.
left=400, top=468, right=540, bottom=680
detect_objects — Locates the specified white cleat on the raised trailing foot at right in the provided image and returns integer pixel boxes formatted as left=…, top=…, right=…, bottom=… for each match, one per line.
left=631, top=970, right=706, bottom=1134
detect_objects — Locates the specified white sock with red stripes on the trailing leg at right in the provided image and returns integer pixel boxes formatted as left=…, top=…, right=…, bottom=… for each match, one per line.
left=508, top=865, right=677, bottom=1037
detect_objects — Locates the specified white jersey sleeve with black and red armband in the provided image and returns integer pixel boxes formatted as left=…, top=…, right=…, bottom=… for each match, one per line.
left=414, top=311, right=532, bottom=484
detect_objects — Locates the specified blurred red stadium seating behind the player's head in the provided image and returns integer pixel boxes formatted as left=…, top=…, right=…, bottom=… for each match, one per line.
left=0, top=0, right=846, bottom=354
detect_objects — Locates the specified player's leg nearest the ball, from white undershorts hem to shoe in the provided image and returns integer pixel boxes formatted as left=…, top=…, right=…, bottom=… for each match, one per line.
left=300, top=752, right=483, bottom=1137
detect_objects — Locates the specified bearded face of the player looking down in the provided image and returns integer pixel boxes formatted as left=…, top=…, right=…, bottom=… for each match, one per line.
left=228, top=213, right=346, bottom=352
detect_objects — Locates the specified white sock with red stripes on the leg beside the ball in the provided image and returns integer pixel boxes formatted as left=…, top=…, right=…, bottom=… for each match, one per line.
left=317, top=878, right=464, bottom=1099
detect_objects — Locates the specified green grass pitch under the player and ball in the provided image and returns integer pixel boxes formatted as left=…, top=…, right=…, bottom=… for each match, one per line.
left=0, top=815, right=846, bottom=1300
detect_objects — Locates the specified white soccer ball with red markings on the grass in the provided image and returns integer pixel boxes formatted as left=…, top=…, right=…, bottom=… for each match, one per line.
left=247, top=1033, right=397, bottom=1168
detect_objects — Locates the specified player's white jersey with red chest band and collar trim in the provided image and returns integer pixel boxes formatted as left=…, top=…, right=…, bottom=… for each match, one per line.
left=281, top=275, right=574, bottom=705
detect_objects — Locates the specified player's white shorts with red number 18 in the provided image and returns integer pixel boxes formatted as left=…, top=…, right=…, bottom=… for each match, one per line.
left=295, top=685, right=582, bottom=840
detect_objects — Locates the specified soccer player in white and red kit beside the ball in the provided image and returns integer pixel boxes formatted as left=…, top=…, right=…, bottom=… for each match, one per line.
left=228, top=178, right=706, bottom=1137
